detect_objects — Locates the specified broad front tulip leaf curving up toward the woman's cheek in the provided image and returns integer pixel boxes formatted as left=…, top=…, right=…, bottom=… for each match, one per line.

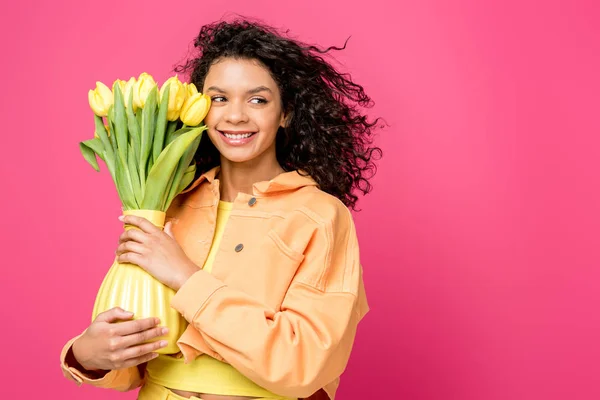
left=141, top=127, right=206, bottom=211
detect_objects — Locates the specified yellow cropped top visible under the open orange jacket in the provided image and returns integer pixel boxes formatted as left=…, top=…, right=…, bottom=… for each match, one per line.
left=146, top=201, right=295, bottom=400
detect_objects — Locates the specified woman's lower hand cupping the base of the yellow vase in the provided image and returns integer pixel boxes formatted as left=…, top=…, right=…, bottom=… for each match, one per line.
left=72, top=307, right=168, bottom=371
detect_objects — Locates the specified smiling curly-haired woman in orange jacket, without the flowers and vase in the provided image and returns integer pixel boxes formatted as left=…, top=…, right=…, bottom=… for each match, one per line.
left=62, top=17, right=380, bottom=400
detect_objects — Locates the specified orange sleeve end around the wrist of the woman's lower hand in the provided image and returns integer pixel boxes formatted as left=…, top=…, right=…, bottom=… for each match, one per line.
left=60, top=335, right=142, bottom=392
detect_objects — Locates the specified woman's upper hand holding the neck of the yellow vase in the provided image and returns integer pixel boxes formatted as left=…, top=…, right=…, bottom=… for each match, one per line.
left=116, top=215, right=200, bottom=290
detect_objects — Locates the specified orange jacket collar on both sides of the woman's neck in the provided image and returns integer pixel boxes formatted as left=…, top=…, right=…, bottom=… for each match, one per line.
left=181, top=166, right=318, bottom=195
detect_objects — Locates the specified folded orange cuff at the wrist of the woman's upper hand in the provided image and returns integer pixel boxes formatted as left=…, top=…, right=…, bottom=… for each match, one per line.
left=171, top=270, right=225, bottom=323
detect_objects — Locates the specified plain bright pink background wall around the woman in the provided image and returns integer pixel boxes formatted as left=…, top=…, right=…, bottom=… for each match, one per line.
left=0, top=0, right=600, bottom=400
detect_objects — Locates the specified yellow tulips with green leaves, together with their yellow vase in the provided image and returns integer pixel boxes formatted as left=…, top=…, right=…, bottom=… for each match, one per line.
left=79, top=73, right=210, bottom=354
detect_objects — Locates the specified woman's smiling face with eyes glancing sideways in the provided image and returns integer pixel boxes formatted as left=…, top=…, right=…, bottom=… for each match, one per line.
left=202, top=58, right=285, bottom=165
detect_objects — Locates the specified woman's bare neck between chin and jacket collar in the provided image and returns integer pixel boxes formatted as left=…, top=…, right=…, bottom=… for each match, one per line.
left=219, top=157, right=285, bottom=202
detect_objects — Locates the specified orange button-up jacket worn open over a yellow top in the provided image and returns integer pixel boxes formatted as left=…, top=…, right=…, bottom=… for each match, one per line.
left=62, top=167, right=369, bottom=399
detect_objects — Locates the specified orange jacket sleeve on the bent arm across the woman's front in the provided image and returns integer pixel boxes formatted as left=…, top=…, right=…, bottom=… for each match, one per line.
left=171, top=205, right=368, bottom=398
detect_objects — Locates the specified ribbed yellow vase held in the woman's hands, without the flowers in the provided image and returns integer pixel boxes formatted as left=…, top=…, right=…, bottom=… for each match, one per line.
left=92, top=210, right=187, bottom=354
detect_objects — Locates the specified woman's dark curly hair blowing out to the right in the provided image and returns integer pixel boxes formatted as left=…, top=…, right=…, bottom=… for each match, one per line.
left=175, top=19, right=382, bottom=210
